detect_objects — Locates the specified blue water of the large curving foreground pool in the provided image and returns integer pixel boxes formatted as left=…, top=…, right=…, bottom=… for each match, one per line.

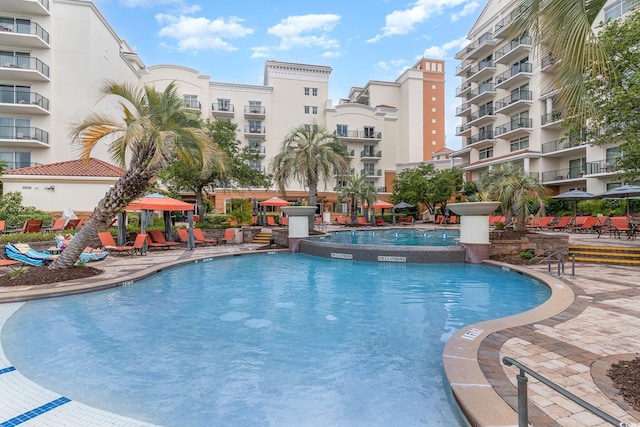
left=0, top=253, right=550, bottom=426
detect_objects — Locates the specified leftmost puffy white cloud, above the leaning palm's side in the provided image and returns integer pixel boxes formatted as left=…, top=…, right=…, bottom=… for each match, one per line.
left=156, top=14, right=254, bottom=52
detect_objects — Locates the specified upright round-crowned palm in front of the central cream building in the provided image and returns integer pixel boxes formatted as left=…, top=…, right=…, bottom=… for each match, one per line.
left=269, top=125, right=349, bottom=230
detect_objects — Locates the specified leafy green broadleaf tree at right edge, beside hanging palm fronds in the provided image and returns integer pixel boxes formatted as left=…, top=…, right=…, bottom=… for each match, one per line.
left=586, top=12, right=640, bottom=182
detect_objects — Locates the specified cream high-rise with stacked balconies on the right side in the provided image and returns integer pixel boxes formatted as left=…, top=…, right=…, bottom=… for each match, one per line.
left=451, top=0, right=628, bottom=193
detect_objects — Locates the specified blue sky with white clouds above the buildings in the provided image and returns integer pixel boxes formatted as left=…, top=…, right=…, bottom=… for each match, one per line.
left=89, top=0, right=485, bottom=149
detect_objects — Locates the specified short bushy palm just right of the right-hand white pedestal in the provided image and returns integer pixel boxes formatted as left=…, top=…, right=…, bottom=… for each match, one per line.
left=480, top=163, right=547, bottom=230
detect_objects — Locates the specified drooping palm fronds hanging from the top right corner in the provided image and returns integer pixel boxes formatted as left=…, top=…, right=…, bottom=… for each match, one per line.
left=512, top=0, right=616, bottom=123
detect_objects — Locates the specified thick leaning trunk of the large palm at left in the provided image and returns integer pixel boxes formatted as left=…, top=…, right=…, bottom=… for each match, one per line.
left=49, top=169, right=150, bottom=270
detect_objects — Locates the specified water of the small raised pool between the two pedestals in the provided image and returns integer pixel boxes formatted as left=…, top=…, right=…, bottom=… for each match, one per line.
left=314, top=229, right=460, bottom=246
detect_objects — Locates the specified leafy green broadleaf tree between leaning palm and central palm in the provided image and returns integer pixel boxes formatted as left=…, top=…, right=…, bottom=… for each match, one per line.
left=161, top=120, right=269, bottom=214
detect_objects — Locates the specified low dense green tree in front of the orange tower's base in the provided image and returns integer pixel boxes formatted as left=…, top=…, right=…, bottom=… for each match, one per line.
left=391, top=163, right=462, bottom=214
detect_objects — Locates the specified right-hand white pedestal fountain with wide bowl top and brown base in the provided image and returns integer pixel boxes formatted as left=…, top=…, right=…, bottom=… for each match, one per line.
left=447, top=202, right=500, bottom=264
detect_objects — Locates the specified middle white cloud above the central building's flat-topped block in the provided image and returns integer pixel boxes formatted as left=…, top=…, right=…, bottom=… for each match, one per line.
left=267, top=14, right=341, bottom=50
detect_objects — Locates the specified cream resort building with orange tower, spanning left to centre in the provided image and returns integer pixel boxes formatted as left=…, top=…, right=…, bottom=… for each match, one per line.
left=0, top=0, right=445, bottom=213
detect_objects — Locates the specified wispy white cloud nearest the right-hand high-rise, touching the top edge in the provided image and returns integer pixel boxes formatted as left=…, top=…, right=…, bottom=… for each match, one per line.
left=367, top=0, right=476, bottom=43
